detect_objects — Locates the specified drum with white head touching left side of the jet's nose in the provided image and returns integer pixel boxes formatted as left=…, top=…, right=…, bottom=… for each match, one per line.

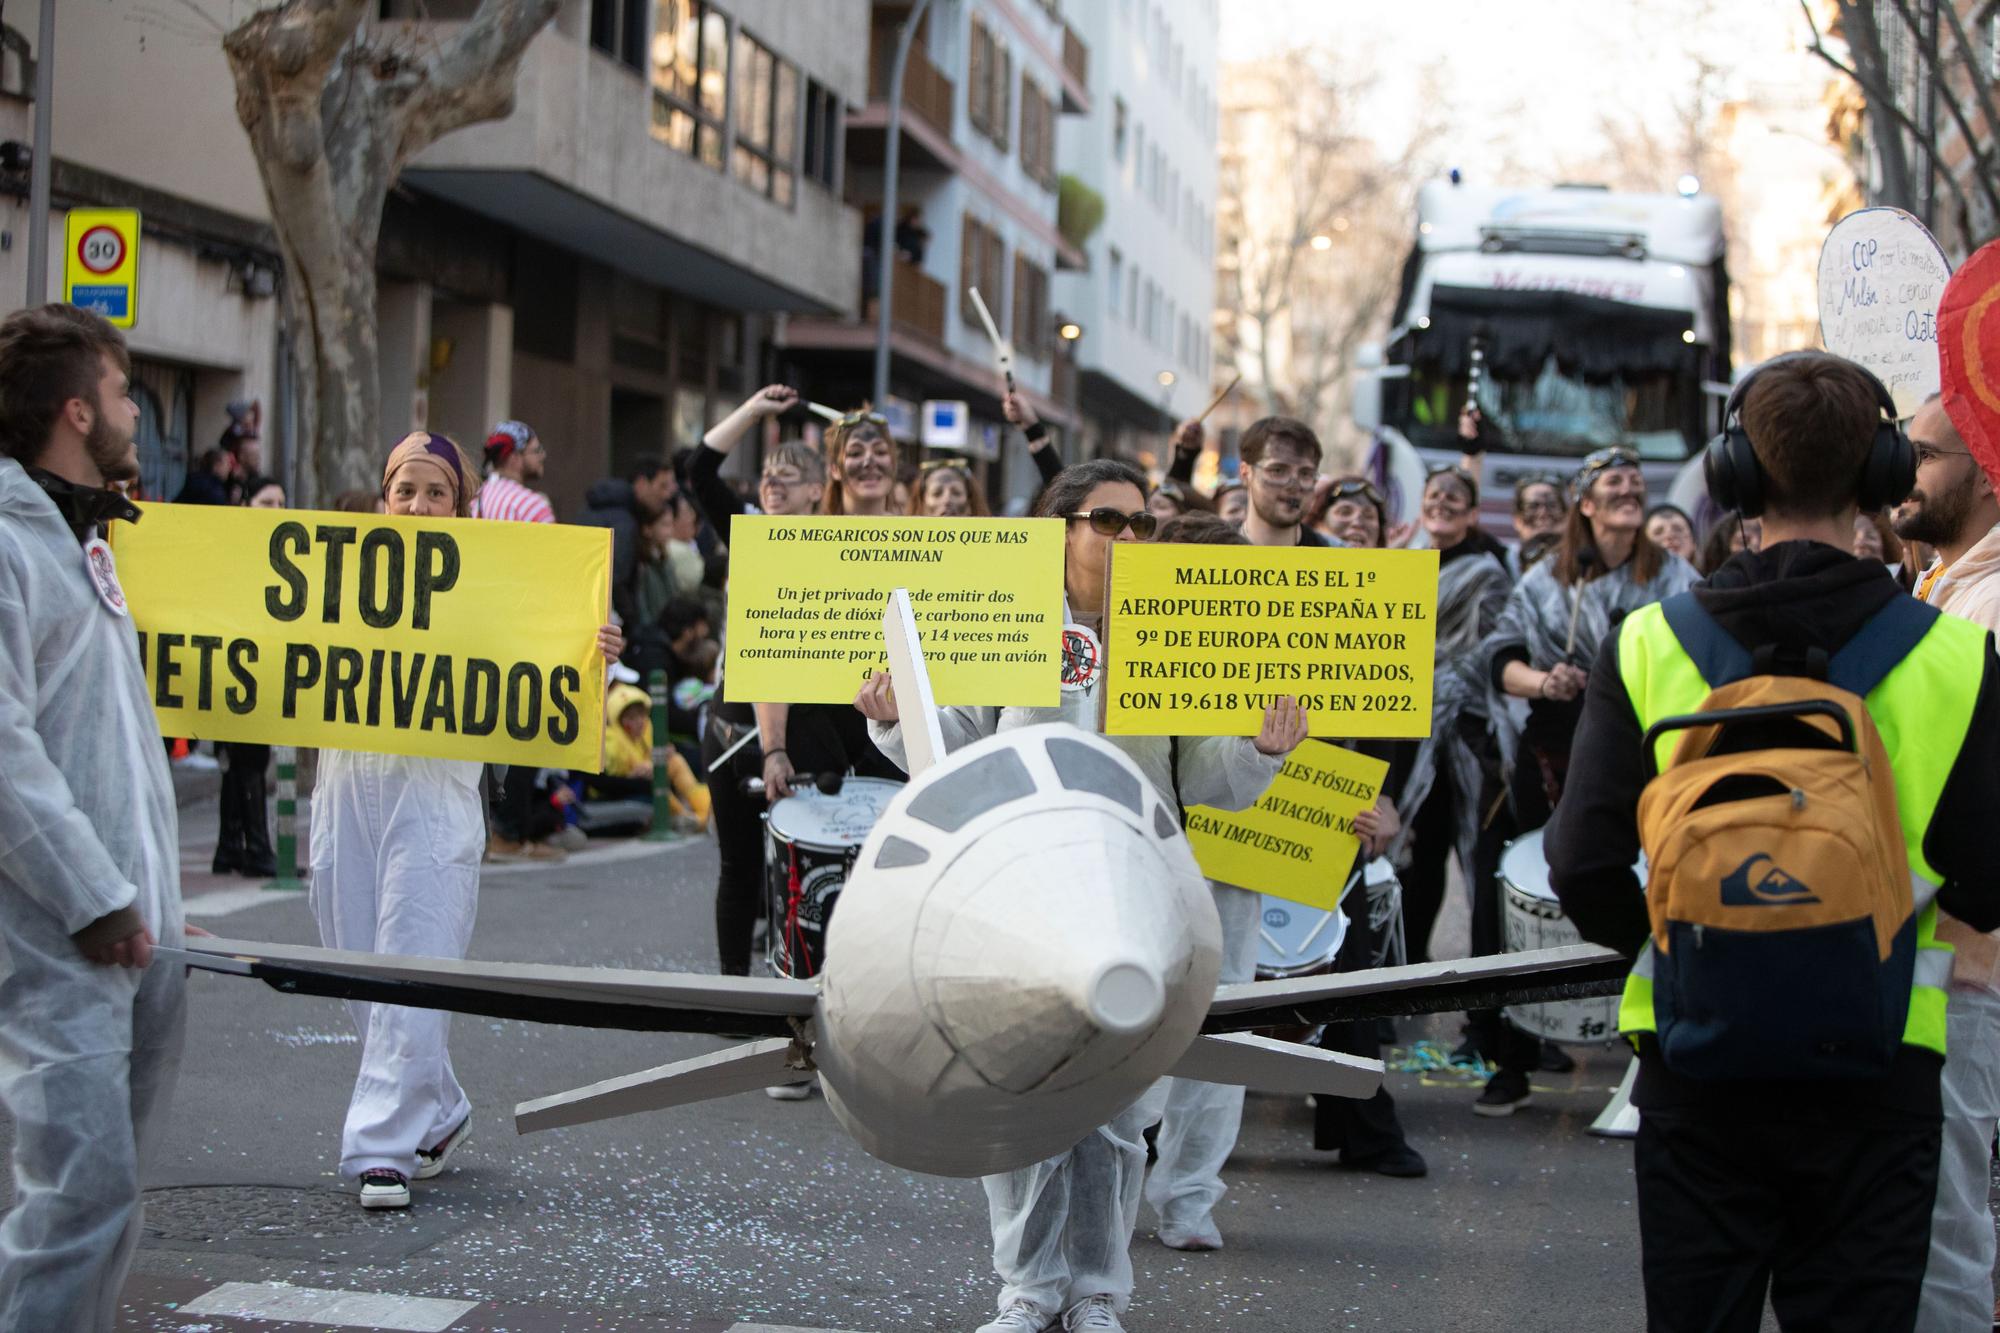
left=764, top=777, right=902, bottom=977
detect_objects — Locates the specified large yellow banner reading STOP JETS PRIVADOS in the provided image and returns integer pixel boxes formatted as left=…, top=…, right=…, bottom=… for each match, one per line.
left=110, top=504, right=612, bottom=771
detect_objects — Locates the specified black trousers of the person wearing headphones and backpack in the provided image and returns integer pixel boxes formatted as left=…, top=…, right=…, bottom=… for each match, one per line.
left=1632, top=1107, right=1942, bottom=1333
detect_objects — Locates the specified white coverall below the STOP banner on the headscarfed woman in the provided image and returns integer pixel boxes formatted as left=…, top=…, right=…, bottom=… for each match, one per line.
left=310, top=751, right=486, bottom=1179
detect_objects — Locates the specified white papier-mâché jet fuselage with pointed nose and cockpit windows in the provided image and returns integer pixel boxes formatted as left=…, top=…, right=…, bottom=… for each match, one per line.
left=814, top=723, right=1220, bottom=1177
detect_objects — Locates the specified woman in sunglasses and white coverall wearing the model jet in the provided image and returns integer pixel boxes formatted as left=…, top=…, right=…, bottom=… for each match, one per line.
left=854, top=472, right=1306, bottom=1333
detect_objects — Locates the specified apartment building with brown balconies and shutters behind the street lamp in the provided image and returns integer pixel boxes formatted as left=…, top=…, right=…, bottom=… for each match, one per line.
left=774, top=0, right=1092, bottom=508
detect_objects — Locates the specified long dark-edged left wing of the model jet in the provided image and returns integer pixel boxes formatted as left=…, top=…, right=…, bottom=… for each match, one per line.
left=154, top=937, right=818, bottom=1041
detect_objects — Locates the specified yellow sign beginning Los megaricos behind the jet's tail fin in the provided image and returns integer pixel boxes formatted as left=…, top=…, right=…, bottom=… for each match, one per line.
left=722, top=516, right=1062, bottom=709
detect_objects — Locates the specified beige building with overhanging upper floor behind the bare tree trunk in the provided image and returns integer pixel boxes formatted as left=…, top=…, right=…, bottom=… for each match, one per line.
left=0, top=0, right=870, bottom=512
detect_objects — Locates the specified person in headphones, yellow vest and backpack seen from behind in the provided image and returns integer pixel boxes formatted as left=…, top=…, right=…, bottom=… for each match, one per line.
left=1548, top=352, right=2000, bottom=1333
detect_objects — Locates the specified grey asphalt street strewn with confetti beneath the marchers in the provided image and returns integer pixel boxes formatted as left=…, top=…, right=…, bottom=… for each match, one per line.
left=0, top=788, right=1984, bottom=1333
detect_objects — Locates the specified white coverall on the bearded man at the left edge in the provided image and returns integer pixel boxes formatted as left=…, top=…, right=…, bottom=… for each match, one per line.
left=0, top=458, right=186, bottom=1333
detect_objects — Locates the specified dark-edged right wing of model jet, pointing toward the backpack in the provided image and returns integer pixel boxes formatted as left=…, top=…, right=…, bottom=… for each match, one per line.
left=1202, top=945, right=1632, bottom=1033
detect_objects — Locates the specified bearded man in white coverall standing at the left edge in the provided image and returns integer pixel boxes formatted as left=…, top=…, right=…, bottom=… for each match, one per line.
left=0, top=306, right=186, bottom=1333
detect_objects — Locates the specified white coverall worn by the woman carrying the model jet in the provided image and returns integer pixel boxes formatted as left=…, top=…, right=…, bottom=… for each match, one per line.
left=868, top=612, right=1284, bottom=1317
